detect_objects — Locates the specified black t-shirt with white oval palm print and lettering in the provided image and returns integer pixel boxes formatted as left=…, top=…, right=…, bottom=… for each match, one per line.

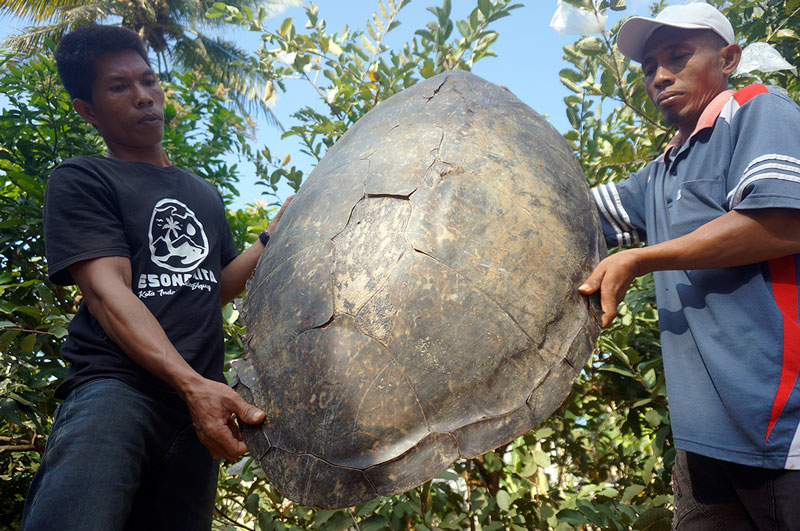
left=44, top=156, right=236, bottom=400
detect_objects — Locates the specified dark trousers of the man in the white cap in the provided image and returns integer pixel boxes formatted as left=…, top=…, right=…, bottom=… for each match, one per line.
left=672, top=450, right=800, bottom=531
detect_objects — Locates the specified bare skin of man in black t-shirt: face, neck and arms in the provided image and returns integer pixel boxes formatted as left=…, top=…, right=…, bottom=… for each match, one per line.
left=69, top=50, right=291, bottom=460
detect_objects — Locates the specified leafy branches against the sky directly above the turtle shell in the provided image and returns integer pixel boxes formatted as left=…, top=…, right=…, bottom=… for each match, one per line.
left=206, top=0, right=521, bottom=160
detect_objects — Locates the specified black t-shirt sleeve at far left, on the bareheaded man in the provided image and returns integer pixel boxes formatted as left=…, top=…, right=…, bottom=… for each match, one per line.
left=44, top=163, right=130, bottom=285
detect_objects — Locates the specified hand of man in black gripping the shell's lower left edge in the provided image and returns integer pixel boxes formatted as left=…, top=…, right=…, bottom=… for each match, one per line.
left=183, top=379, right=266, bottom=461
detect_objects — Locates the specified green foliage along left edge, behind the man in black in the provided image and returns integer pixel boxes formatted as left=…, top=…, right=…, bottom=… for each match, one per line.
left=0, top=47, right=101, bottom=525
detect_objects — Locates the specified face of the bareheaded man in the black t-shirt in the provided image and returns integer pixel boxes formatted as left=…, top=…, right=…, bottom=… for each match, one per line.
left=76, top=50, right=164, bottom=152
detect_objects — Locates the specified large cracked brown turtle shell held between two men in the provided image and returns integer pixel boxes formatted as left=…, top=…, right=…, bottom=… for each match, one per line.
left=236, top=71, right=605, bottom=508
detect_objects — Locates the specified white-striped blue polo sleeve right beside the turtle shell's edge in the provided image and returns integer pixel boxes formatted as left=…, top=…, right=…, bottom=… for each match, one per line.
left=592, top=163, right=653, bottom=247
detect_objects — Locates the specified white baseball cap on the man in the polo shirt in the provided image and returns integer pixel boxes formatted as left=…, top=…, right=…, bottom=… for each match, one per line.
left=617, top=2, right=735, bottom=63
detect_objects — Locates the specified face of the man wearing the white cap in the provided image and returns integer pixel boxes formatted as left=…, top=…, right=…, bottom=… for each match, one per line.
left=642, top=27, right=730, bottom=133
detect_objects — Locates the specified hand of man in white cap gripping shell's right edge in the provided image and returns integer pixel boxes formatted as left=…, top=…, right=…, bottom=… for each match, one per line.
left=578, top=249, right=644, bottom=328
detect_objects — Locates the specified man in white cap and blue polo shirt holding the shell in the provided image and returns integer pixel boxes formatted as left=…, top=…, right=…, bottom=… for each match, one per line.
left=579, top=3, right=800, bottom=530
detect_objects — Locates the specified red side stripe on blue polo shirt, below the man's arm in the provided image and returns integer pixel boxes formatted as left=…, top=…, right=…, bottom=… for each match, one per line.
left=764, top=255, right=800, bottom=442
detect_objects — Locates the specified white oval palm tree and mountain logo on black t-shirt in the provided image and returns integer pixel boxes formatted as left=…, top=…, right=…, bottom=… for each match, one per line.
left=149, top=198, right=208, bottom=273
